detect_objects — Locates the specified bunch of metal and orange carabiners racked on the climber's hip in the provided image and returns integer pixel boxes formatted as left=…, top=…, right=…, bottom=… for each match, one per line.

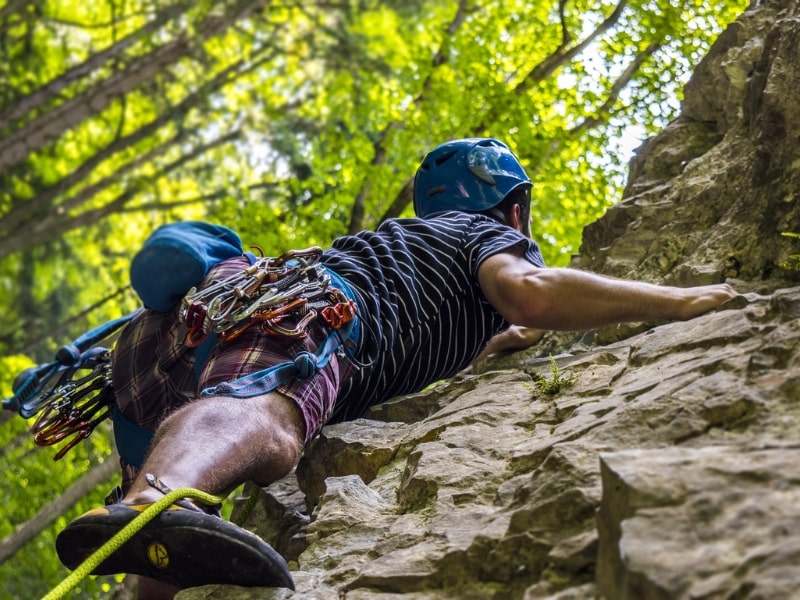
left=179, top=247, right=355, bottom=347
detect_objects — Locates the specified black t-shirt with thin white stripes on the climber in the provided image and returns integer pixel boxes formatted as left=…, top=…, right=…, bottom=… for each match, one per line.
left=322, top=212, right=544, bottom=423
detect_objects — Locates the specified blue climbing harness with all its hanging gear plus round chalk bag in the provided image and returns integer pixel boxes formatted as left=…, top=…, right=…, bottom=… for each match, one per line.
left=3, top=221, right=360, bottom=467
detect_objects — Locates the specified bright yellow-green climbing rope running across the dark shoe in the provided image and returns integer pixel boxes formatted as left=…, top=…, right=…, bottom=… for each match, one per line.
left=42, top=488, right=224, bottom=600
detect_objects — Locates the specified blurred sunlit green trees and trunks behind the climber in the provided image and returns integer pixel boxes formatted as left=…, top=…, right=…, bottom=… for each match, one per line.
left=0, top=0, right=747, bottom=597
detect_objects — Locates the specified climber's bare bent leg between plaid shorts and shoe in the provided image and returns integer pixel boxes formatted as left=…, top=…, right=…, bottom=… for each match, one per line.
left=123, top=392, right=304, bottom=504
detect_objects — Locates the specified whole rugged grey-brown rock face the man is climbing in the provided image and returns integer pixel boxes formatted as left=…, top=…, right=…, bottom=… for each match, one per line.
left=178, top=0, right=800, bottom=600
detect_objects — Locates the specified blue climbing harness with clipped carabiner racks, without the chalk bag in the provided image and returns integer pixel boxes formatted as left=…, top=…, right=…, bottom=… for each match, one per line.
left=3, top=247, right=360, bottom=466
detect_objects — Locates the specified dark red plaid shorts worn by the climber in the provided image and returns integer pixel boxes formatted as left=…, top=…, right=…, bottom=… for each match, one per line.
left=112, top=257, right=352, bottom=490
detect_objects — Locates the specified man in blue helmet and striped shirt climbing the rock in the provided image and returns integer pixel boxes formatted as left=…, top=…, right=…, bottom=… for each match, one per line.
left=57, top=139, right=736, bottom=597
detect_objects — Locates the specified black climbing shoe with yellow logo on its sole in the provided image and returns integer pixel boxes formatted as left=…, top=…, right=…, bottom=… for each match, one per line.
left=56, top=504, right=294, bottom=589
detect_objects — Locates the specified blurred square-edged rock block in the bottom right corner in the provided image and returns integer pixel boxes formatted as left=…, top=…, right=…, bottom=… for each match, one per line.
left=598, top=443, right=800, bottom=600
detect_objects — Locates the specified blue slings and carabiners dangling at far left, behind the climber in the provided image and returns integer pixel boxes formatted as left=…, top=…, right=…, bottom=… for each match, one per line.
left=3, top=311, right=138, bottom=460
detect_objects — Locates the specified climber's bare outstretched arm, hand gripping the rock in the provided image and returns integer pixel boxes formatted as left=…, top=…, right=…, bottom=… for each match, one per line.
left=478, top=253, right=737, bottom=331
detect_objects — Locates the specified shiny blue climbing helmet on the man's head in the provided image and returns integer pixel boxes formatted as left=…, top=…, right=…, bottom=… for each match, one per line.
left=414, top=138, right=531, bottom=217
